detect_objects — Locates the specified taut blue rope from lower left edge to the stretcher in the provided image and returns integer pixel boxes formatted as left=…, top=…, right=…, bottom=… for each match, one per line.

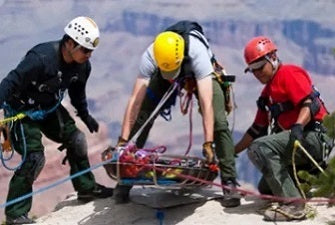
left=0, top=156, right=111, bottom=209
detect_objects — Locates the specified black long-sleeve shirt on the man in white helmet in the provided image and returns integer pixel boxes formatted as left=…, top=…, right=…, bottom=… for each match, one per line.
left=0, top=41, right=91, bottom=117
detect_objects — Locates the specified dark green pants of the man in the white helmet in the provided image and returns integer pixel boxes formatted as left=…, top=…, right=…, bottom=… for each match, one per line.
left=5, top=106, right=95, bottom=218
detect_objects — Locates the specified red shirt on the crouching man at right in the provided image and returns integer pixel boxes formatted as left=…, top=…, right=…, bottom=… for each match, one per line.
left=254, top=65, right=327, bottom=129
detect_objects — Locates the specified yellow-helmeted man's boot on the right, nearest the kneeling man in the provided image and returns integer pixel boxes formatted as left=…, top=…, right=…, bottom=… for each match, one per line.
left=221, top=178, right=241, bottom=208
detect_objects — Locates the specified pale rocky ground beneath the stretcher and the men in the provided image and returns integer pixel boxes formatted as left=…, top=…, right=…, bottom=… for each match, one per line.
left=37, top=188, right=335, bottom=225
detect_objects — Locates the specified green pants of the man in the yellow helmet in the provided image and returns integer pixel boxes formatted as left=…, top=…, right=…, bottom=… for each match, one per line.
left=129, top=75, right=236, bottom=178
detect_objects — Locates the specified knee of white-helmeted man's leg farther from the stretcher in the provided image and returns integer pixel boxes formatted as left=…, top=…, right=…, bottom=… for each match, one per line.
left=15, top=151, right=45, bottom=183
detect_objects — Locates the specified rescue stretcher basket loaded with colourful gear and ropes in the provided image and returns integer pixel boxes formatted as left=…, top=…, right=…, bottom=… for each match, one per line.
left=102, top=150, right=218, bottom=189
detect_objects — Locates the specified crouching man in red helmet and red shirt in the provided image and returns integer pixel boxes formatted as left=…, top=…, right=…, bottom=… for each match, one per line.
left=235, top=36, right=331, bottom=221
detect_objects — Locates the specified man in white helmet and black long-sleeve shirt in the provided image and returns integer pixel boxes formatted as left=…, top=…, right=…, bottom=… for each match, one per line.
left=0, top=17, right=113, bottom=224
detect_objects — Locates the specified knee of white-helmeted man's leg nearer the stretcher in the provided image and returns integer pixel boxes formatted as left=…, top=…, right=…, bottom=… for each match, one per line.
left=66, top=130, right=87, bottom=158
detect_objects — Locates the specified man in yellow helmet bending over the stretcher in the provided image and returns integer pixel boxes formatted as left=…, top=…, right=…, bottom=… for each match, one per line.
left=114, top=21, right=240, bottom=207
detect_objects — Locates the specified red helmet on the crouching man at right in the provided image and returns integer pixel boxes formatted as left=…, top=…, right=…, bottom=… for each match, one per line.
left=244, top=36, right=277, bottom=64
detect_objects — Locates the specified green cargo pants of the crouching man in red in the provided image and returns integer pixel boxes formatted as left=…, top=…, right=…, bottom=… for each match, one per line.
left=248, top=131, right=329, bottom=197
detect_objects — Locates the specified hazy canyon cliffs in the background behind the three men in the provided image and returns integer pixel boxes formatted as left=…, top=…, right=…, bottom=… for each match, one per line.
left=0, top=0, right=335, bottom=221
